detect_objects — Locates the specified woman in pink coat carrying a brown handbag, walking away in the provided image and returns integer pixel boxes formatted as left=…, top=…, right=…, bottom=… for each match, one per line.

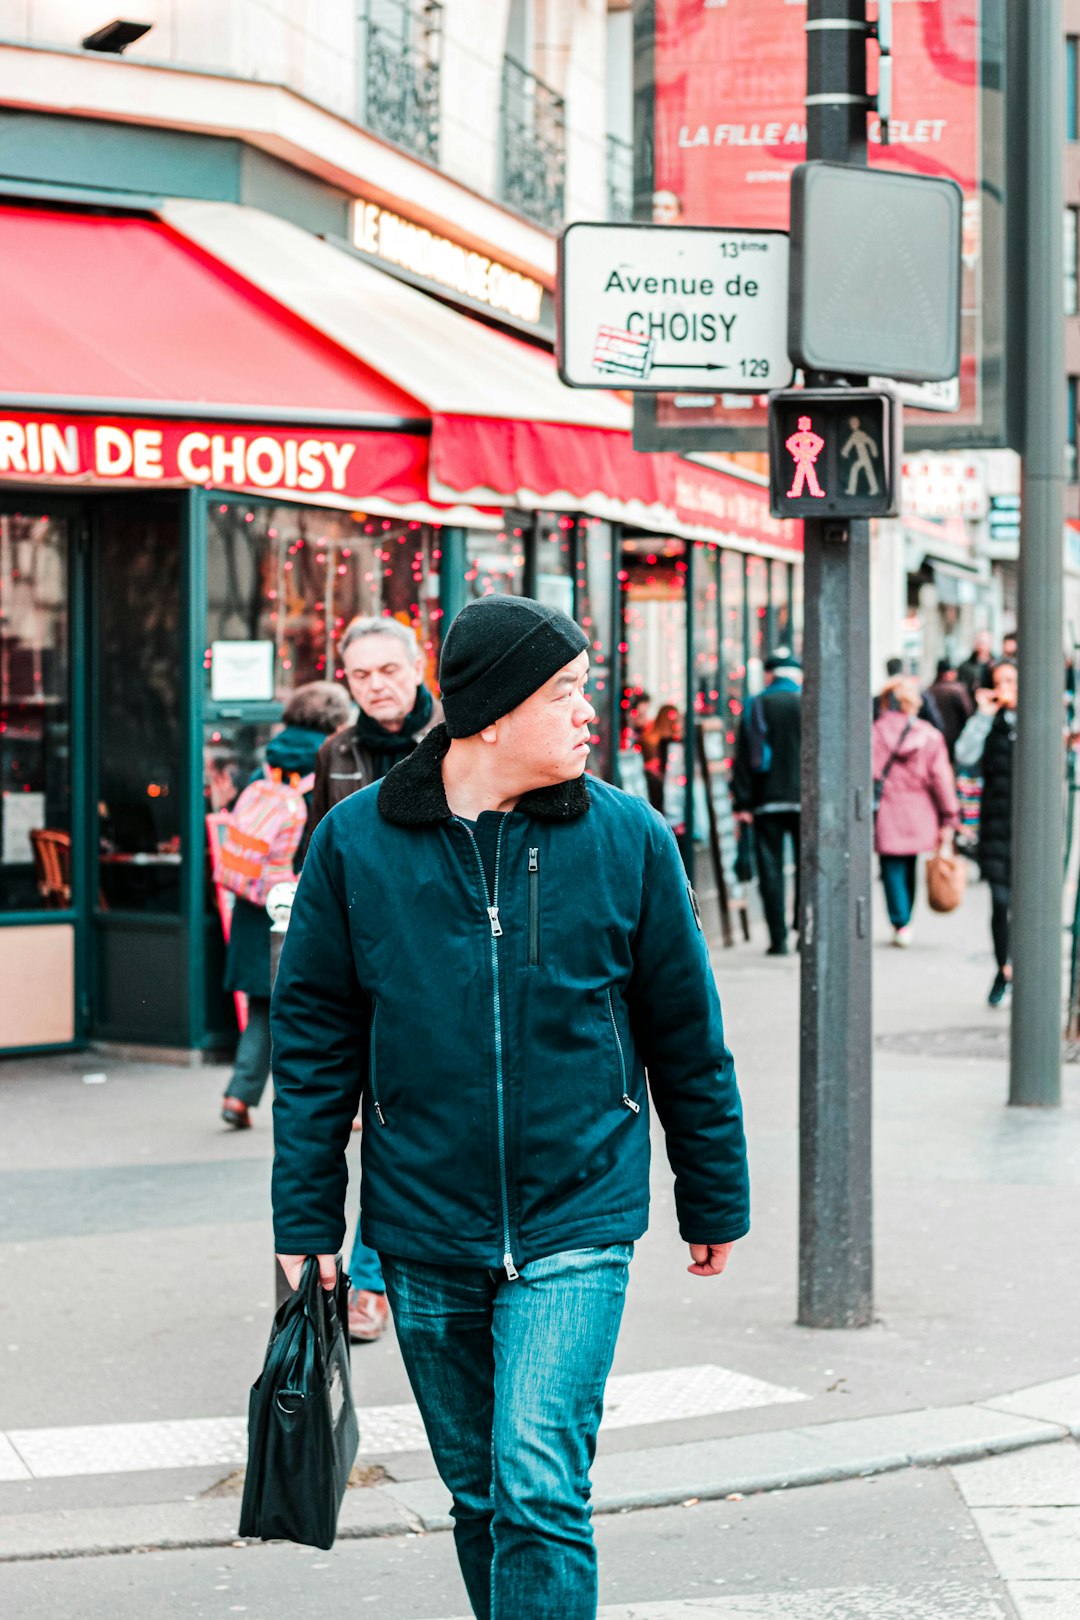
left=873, top=676, right=960, bottom=946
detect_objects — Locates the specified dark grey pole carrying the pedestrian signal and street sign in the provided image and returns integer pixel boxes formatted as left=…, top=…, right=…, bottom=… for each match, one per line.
left=798, top=0, right=874, bottom=1327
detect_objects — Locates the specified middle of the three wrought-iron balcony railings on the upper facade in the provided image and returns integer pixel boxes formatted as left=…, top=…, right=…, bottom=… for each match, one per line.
left=499, top=57, right=567, bottom=227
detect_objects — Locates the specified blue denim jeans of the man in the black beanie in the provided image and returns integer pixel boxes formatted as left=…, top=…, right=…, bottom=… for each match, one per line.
left=382, top=1243, right=633, bottom=1620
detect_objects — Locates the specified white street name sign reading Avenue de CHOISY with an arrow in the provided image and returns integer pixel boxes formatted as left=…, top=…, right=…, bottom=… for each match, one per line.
left=555, top=224, right=793, bottom=394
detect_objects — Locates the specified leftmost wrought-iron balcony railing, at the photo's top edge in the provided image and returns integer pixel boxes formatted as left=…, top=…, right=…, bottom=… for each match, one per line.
left=358, top=0, right=444, bottom=164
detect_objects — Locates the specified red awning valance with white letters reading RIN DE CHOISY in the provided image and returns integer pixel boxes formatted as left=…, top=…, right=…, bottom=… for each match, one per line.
left=0, top=411, right=427, bottom=501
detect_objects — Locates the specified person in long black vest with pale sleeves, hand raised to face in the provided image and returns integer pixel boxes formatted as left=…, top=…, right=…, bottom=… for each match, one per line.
left=957, top=663, right=1017, bottom=1008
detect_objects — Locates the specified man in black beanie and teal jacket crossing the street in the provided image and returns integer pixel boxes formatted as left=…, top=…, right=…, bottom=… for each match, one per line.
left=272, top=596, right=748, bottom=1620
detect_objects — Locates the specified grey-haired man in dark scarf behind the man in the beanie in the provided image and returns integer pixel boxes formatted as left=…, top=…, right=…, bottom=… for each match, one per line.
left=308, top=617, right=442, bottom=1345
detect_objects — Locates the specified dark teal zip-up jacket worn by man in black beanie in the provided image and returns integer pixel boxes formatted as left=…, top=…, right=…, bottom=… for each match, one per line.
left=272, top=726, right=750, bottom=1275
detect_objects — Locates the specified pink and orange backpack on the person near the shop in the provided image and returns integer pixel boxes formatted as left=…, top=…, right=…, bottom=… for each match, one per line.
left=219, top=766, right=314, bottom=906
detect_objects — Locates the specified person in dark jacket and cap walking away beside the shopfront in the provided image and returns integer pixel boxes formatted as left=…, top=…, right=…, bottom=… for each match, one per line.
left=732, top=646, right=803, bottom=956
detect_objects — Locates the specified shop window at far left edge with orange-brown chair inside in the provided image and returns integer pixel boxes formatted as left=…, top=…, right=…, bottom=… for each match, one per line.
left=0, top=514, right=71, bottom=912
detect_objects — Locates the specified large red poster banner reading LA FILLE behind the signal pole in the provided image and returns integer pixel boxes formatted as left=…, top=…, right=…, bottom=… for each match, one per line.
left=653, top=0, right=981, bottom=426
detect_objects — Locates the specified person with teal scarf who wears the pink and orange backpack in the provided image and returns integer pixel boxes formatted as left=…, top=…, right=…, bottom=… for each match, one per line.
left=222, top=680, right=348, bottom=1131
